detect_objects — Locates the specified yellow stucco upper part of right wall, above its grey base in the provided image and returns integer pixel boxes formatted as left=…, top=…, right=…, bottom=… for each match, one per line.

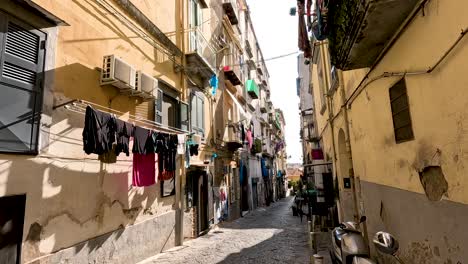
left=345, top=1, right=468, bottom=204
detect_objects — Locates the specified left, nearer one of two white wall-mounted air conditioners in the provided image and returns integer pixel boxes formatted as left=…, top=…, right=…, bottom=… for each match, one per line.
left=101, top=55, right=136, bottom=90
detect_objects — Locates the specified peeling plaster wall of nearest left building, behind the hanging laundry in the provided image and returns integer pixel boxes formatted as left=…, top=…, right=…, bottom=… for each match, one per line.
left=0, top=0, right=182, bottom=263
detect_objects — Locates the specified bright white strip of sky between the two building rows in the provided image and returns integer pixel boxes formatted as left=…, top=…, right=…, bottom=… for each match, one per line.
left=247, top=0, right=302, bottom=163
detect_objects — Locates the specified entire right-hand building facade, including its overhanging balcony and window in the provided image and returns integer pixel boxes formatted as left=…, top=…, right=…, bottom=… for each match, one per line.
left=311, top=0, right=468, bottom=263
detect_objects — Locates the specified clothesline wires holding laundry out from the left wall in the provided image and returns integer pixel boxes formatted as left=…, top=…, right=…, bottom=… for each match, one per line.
left=60, top=100, right=188, bottom=134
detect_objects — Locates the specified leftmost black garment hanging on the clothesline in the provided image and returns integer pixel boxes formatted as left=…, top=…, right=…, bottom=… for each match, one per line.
left=82, top=106, right=116, bottom=155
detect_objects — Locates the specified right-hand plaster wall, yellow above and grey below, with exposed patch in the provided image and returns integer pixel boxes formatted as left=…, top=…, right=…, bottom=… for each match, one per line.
left=344, top=0, right=468, bottom=263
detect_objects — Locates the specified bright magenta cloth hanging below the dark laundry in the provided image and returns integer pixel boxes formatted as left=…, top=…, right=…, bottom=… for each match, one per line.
left=132, top=152, right=156, bottom=187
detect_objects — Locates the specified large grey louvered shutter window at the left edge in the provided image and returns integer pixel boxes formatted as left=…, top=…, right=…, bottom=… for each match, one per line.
left=0, top=12, right=46, bottom=154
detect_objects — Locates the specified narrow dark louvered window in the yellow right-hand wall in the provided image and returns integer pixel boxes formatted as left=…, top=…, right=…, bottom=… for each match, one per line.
left=389, top=78, right=414, bottom=143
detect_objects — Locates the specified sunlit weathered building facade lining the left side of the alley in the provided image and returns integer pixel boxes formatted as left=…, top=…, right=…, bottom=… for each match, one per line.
left=0, top=0, right=286, bottom=263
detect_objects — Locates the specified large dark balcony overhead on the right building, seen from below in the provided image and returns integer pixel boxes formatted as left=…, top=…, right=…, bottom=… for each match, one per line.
left=328, top=0, right=420, bottom=70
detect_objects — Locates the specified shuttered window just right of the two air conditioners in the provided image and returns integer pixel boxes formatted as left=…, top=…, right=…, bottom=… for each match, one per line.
left=154, top=80, right=189, bottom=131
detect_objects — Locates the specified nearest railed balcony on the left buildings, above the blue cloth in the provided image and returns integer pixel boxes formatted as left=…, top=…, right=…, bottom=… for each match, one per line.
left=185, top=28, right=216, bottom=87
